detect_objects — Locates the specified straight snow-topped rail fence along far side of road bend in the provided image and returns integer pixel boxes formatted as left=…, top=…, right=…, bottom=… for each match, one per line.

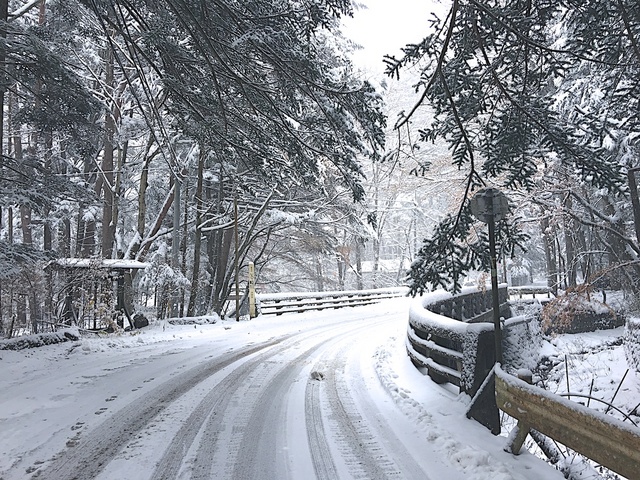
left=256, top=287, right=408, bottom=315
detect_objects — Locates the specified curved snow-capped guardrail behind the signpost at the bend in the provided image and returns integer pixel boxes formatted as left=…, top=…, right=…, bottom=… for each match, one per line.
left=406, top=286, right=512, bottom=396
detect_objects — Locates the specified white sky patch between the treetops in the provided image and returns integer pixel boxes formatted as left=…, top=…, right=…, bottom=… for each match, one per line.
left=342, top=0, right=449, bottom=72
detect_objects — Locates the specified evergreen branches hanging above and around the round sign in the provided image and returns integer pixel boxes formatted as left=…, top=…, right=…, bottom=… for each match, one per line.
left=386, top=0, right=640, bottom=293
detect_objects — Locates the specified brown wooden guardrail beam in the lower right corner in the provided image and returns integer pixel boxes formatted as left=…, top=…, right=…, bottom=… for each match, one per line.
left=494, top=366, right=640, bottom=479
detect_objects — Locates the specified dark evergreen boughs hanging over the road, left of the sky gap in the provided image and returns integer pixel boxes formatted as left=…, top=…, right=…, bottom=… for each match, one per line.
left=86, top=0, right=385, bottom=199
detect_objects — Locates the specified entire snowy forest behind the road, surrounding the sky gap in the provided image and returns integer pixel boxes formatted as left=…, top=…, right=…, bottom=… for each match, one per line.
left=0, top=0, right=640, bottom=337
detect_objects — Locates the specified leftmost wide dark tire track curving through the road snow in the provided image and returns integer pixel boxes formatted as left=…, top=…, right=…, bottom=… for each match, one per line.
left=33, top=337, right=288, bottom=480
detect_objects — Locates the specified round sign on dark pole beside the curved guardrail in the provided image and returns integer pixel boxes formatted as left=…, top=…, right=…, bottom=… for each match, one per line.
left=469, top=188, right=509, bottom=363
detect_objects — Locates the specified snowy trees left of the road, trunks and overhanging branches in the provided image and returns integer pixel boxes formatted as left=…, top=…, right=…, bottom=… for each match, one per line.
left=0, top=0, right=385, bottom=336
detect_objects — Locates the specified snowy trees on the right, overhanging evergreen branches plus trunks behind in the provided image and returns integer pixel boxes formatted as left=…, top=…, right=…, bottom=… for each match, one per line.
left=387, top=0, right=640, bottom=302
